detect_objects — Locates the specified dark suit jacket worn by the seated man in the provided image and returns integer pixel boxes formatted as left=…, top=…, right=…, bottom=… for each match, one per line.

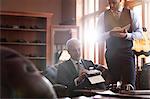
left=57, top=60, right=105, bottom=90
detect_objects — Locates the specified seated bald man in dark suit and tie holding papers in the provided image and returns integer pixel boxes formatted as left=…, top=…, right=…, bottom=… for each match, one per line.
left=57, top=39, right=105, bottom=95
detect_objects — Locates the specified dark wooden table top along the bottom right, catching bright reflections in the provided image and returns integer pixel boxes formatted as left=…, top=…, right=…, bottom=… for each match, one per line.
left=75, top=90, right=150, bottom=99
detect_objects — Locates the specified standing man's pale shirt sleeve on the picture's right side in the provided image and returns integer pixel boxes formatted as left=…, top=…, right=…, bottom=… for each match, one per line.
left=126, top=10, right=143, bottom=40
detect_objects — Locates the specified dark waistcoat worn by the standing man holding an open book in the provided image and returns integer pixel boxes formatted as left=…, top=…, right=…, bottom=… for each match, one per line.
left=104, top=9, right=133, bottom=51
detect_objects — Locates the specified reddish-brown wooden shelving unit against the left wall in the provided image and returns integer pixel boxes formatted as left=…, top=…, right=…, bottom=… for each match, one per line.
left=0, top=11, right=53, bottom=71
